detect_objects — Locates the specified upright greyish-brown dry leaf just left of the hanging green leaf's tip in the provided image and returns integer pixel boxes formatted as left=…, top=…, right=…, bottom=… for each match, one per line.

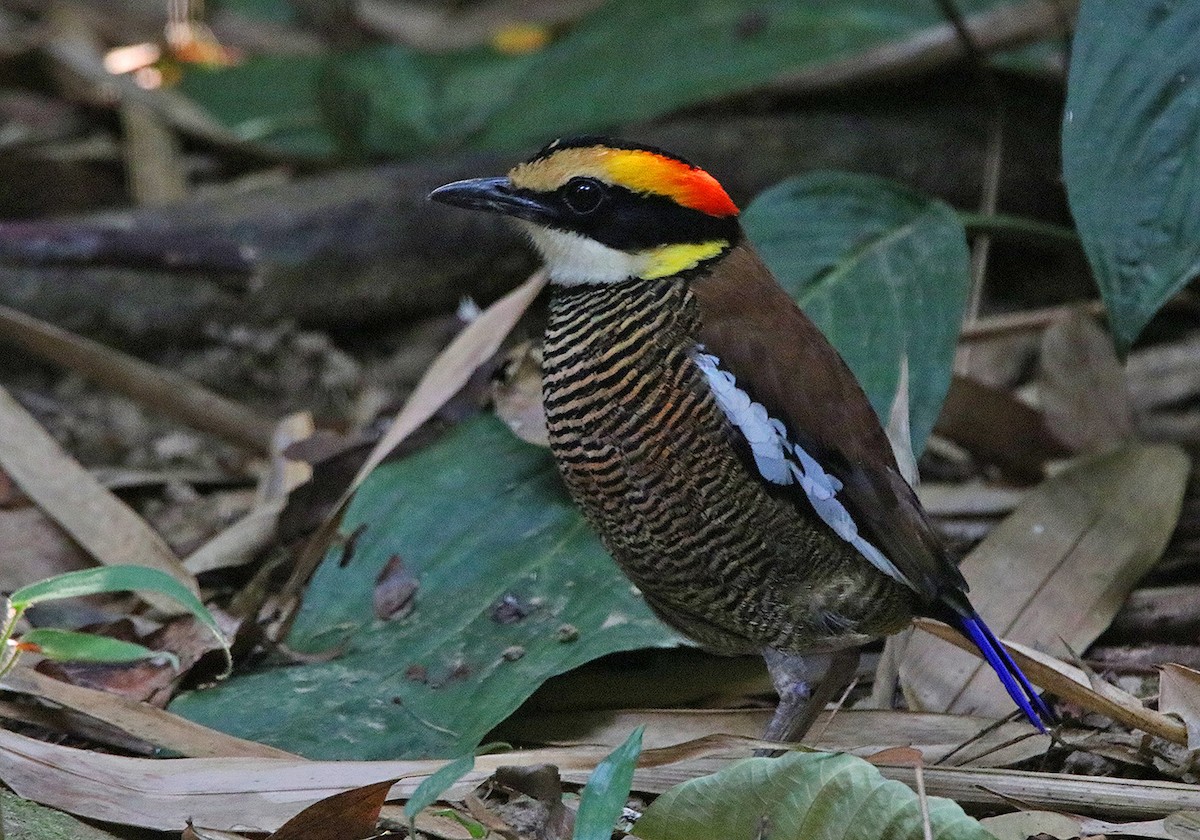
left=1040, top=310, right=1134, bottom=452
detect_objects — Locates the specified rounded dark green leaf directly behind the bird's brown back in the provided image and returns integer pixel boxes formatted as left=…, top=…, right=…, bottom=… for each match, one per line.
left=742, top=173, right=971, bottom=455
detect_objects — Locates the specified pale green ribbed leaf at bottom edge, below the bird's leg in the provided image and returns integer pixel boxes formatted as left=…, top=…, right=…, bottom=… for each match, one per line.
left=635, top=752, right=995, bottom=840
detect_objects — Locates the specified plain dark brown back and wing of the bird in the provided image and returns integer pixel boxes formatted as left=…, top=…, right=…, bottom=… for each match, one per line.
left=692, top=242, right=966, bottom=600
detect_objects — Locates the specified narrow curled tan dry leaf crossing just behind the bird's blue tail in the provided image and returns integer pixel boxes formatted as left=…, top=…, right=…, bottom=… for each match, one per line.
left=914, top=618, right=1188, bottom=744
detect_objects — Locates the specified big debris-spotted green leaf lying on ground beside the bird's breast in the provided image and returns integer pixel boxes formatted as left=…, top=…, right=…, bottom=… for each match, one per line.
left=172, top=416, right=678, bottom=758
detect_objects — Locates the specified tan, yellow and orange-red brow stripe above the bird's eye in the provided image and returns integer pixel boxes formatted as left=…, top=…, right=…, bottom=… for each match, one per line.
left=509, top=140, right=738, bottom=217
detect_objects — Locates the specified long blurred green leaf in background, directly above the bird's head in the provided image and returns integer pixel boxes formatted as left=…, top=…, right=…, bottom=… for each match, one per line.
left=475, top=0, right=1002, bottom=148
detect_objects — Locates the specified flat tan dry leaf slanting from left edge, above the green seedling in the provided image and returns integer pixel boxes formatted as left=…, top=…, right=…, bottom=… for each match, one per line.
left=0, top=388, right=199, bottom=614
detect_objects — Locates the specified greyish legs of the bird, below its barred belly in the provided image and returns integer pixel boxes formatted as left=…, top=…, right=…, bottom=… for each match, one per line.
left=763, top=647, right=858, bottom=744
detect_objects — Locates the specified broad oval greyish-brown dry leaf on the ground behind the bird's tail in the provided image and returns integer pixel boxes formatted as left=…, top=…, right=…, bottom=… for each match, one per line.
left=900, top=444, right=1189, bottom=718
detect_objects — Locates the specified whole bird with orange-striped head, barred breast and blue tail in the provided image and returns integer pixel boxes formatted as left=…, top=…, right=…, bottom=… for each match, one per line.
left=430, top=137, right=1052, bottom=740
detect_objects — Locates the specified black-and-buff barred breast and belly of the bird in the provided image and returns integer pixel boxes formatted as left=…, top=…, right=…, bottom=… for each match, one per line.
left=544, top=277, right=911, bottom=653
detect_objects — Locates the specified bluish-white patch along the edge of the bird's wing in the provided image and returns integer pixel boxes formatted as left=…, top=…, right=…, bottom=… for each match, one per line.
left=695, top=347, right=916, bottom=589
